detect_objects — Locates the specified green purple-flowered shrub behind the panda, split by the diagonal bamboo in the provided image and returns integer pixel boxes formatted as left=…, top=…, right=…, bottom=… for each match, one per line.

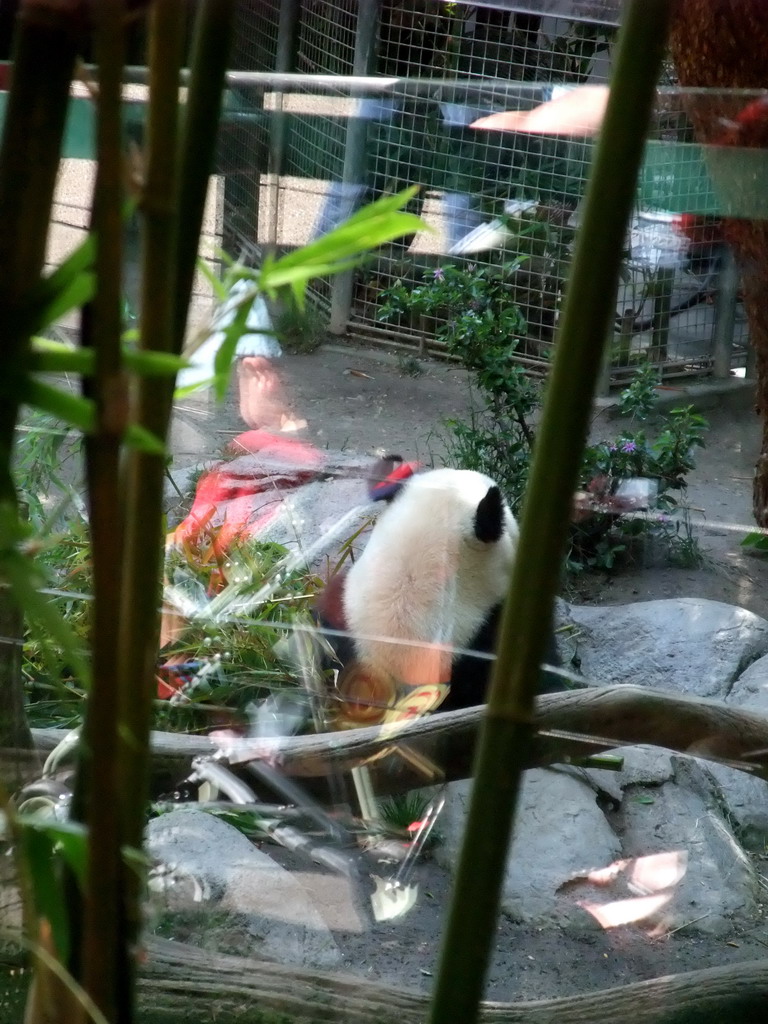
left=380, top=264, right=708, bottom=571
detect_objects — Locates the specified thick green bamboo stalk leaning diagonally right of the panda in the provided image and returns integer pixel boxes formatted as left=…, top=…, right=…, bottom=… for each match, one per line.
left=429, top=0, right=671, bottom=1024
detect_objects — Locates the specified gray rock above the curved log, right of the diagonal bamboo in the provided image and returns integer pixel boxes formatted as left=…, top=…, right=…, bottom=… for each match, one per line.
left=561, top=598, right=768, bottom=697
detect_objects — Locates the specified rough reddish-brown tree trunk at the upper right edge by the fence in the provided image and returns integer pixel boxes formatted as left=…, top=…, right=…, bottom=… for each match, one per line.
left=670, top=0, right=768, bottom=527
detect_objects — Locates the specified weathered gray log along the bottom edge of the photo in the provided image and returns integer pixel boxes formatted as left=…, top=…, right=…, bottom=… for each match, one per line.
left=138, top=939, right=768, bottom=1024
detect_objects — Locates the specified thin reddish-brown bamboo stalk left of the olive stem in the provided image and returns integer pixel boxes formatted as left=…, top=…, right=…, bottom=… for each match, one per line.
left=75, top=0, right=130, bottom=1020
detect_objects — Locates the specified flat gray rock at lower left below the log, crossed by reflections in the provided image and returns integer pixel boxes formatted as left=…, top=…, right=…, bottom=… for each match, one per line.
left=146, top=808, right=342, bottom=968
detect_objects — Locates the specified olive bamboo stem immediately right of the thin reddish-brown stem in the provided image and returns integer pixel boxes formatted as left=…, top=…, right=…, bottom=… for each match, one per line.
left=116, top=0, right=183, bottom=1024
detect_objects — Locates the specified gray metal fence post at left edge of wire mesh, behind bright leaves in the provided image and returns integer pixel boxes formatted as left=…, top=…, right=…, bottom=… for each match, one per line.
left=329, top=0, right=379, bottom=334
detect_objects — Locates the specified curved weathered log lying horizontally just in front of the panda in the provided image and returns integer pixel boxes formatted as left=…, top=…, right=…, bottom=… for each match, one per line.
left=34, top=685, right=768, bottom=794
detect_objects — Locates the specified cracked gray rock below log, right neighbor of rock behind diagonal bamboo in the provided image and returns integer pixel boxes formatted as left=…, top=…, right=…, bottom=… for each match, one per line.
left=615, top=757, right=758, bottom=935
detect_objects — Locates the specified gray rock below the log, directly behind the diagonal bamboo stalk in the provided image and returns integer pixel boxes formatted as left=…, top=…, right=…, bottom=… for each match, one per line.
left=436, top=768, right=621, bottom=929
